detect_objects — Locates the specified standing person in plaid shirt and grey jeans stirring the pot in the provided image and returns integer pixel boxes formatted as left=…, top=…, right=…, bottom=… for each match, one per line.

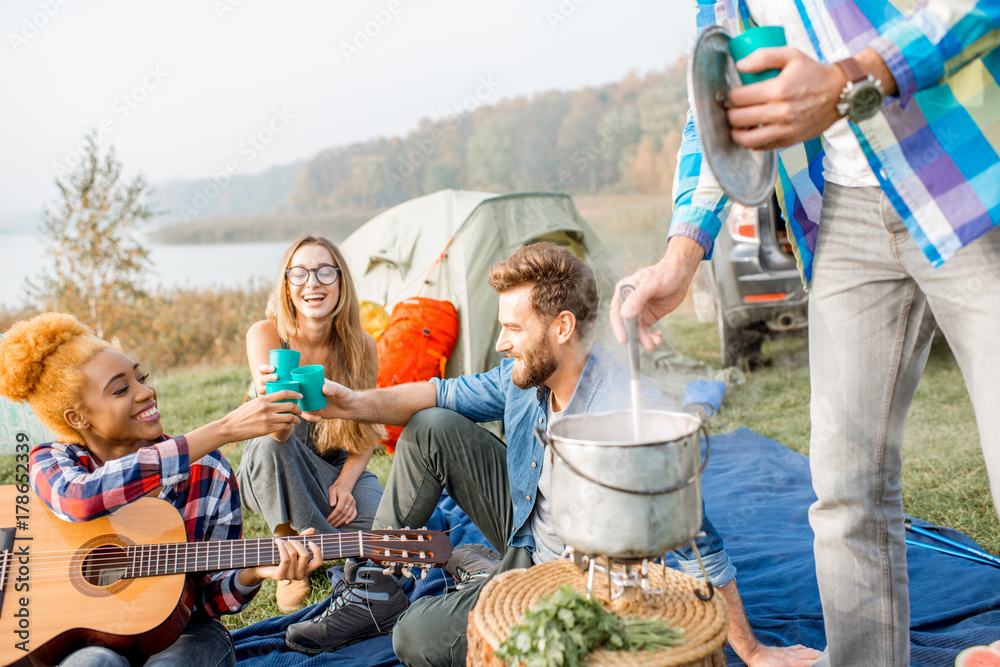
left=611, top=0, right=1000, bottom=667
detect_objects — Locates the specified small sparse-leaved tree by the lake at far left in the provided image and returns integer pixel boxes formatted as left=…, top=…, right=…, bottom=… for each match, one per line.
left=28, top=136, right=154, bottom=337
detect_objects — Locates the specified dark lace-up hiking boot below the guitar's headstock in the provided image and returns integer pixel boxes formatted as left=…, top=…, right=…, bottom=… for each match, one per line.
left=285, top=565, right=410, bottom=655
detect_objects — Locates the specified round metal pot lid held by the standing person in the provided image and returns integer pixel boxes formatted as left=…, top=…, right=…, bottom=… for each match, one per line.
left=688, top=26, right=778, bottom=206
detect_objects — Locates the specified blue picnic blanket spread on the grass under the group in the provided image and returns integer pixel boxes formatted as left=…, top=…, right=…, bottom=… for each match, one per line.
left=233, top=428, right=1000, bottom=667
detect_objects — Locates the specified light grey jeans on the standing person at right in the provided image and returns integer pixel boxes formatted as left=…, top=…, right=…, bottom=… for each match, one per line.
left=809, top=183, right=1000, bottom=667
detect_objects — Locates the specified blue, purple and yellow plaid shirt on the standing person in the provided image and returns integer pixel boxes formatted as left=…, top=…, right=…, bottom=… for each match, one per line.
left=668, top=0, right=1000, bottom=281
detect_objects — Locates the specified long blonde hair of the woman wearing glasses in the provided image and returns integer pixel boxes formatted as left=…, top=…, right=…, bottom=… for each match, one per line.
left=266, top=236, right=385, bottom=454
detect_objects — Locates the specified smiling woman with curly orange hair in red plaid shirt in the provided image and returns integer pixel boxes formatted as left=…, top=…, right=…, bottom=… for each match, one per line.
left=0, top=313, right=323, bottom=667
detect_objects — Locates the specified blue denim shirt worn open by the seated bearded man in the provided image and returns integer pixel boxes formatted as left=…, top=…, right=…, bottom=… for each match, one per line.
left=431, top=343, right=736, bottom=586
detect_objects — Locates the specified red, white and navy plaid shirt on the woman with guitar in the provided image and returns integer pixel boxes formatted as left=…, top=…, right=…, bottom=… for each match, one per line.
left=30, top=436, right=256, bottom=617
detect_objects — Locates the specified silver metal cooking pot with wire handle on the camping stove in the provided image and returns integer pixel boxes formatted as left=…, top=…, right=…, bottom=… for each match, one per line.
left=536, top=410, right=708, bottom=559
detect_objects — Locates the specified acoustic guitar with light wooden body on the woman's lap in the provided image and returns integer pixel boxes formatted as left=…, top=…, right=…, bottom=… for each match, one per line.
left=0, top=485, right=451, bottom=665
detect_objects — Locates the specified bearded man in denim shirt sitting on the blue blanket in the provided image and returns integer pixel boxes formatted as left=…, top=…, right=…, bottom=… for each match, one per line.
left=285, top=243, right=819, bottom=667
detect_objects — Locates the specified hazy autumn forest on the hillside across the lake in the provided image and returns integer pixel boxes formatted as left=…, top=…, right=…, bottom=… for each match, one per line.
left=154, top=61, right=687, bottom=222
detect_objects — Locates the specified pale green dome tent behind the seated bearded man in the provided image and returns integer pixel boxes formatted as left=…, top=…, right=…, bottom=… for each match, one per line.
left=340, top=190, right=737, bottom=401
